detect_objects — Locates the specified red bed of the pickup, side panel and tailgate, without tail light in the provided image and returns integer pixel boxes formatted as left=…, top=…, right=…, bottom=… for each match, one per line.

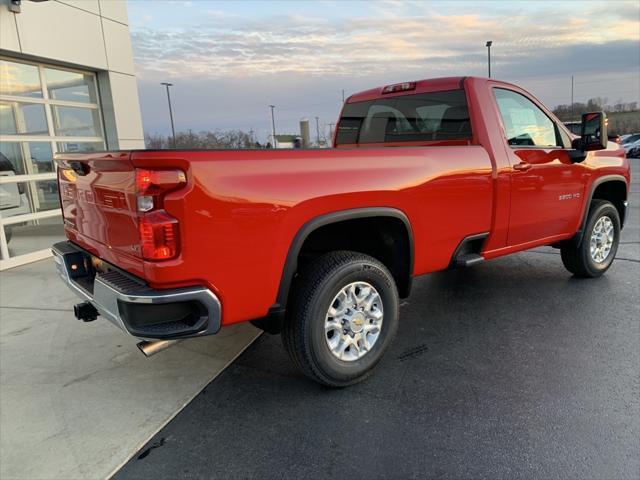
left=57, top=146, right=493, bottom=324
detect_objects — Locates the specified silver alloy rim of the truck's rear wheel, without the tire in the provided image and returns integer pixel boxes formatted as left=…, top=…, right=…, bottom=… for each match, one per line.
left=324, top=282, right=384, bottom=362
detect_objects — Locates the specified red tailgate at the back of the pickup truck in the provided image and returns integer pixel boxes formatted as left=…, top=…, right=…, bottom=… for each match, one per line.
left=56, top=152, right=142, bottom=270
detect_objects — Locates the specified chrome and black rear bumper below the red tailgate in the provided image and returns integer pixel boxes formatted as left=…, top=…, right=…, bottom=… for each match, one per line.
left=52, top=242, right=221, bottom=340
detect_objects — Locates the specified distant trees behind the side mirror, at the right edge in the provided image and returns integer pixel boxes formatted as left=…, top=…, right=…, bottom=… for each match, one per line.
left=553, top=97, right=640, bottom=135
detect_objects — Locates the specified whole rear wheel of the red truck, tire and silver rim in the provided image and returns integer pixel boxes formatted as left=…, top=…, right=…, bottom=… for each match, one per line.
left=282, top=251, right=399, bottom=387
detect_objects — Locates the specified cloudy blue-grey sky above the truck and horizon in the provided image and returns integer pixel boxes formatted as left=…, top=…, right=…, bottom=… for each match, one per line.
left=128, top=0, right=640, bottom=140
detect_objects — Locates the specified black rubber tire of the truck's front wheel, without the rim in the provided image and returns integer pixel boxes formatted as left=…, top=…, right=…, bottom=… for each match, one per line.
left=560, top=200, right=620, bottom=278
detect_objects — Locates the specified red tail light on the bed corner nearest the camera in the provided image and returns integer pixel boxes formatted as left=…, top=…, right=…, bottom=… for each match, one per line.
left=136, top=169, right=187, bottom=260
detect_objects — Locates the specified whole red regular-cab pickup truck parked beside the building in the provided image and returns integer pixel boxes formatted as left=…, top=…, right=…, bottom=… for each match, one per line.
left=53, top=77, right=630, bottom=386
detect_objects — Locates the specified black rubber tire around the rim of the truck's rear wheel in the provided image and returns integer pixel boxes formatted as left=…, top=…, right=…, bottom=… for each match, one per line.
left=282, top=251, right=399, bottom=387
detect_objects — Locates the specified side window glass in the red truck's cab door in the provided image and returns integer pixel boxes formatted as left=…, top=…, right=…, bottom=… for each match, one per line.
left=494, top=88, right=562, bottom=147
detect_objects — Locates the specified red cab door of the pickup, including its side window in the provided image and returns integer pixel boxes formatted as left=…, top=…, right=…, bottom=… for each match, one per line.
left=494, top=88, right=585, bottom=245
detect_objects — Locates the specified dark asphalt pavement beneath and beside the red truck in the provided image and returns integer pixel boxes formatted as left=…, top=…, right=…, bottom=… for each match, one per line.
left=115, top=160, right=640, bottom=479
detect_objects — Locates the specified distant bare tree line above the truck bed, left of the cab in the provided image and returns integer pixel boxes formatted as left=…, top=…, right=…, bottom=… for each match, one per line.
left=144, top=130, right=263, bottom=150
